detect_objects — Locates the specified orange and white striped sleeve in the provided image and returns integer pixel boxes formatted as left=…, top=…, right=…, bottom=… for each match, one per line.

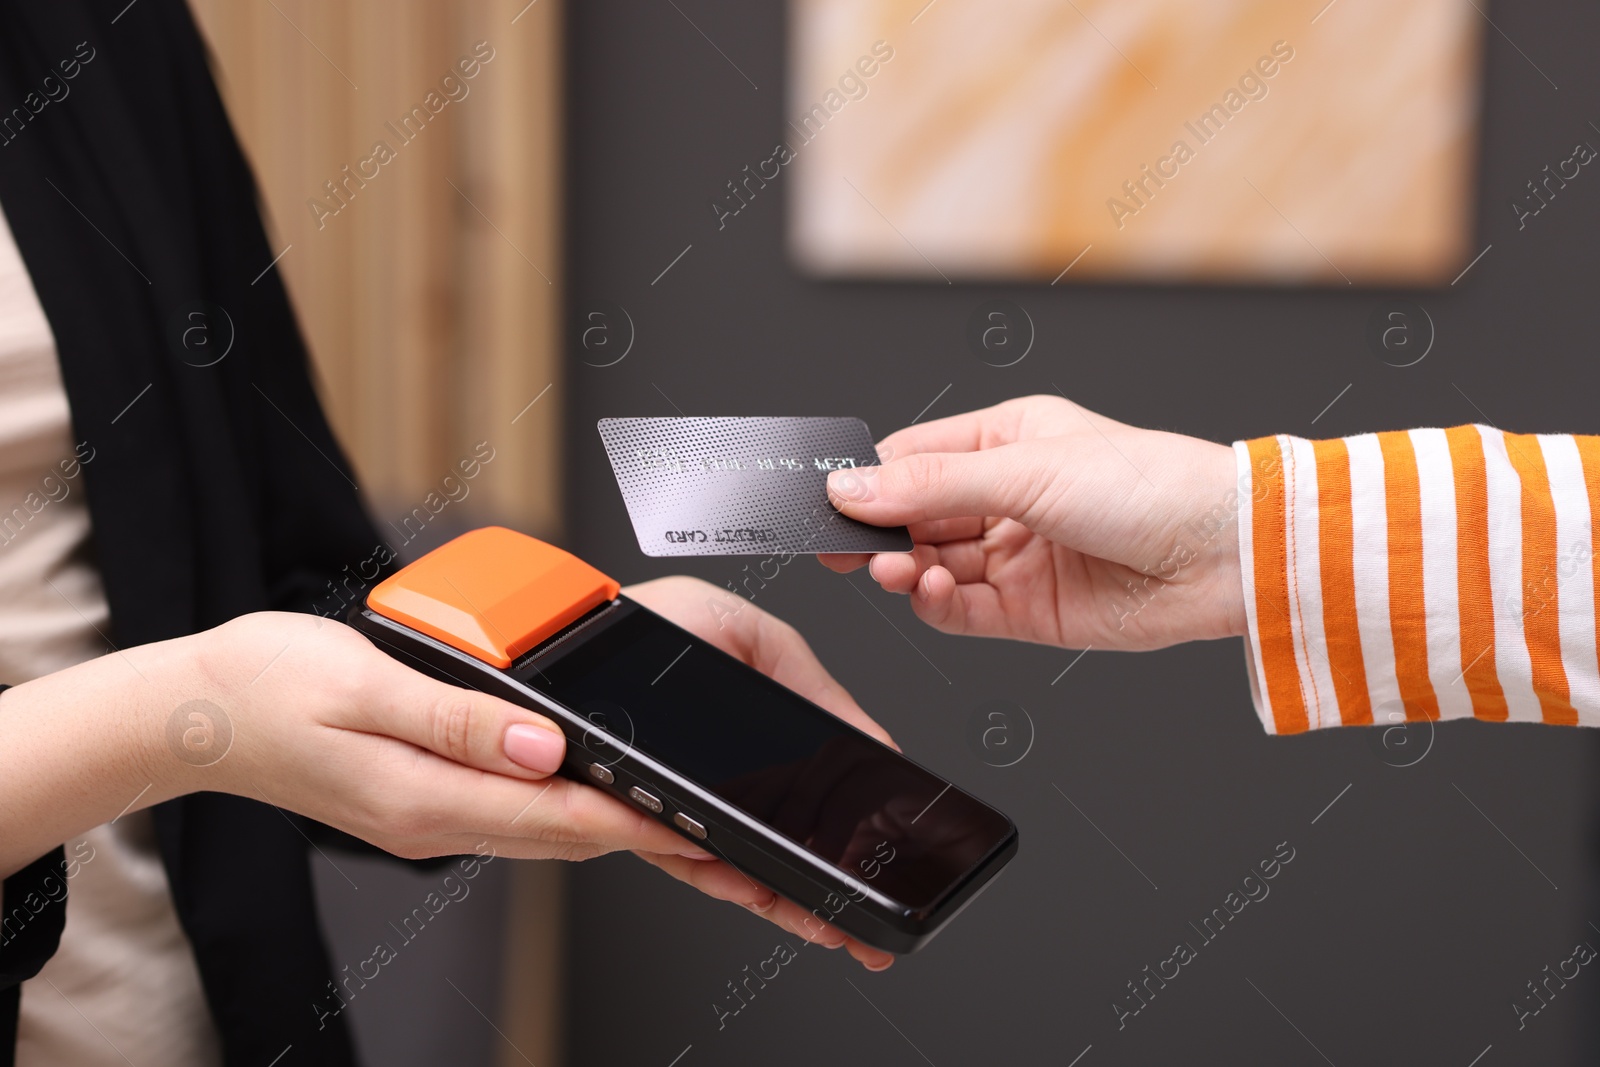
left=1234, top=426, right=1600, bottom=734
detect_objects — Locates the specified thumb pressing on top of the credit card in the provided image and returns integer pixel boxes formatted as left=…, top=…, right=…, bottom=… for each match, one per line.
left=827, top=442, right=1059, bottom=526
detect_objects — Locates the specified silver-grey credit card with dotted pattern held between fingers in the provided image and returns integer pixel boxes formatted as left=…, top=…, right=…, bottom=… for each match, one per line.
left=600, top=418, right=910, bottom=555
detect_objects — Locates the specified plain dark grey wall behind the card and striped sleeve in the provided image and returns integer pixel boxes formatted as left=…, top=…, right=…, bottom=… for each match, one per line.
left=568, top=0, right=1600, bottom=1067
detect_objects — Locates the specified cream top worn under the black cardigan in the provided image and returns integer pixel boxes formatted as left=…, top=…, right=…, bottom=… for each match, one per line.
left=0, top=202, right=222, bottom=1067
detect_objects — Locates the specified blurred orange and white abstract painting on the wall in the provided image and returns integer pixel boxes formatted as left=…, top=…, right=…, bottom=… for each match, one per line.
left=787, top=0, right=1485, bottom=286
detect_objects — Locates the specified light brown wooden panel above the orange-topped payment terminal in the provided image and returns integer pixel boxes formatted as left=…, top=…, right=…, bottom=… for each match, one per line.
left=194, top=0, right=562, bottom=534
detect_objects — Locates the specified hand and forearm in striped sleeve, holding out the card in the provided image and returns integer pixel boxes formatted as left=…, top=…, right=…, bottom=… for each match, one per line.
left=824, top=397, right=1600, bottom=733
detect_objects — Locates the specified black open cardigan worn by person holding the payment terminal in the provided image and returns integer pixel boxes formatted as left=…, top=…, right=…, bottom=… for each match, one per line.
left=0, top=0, right=392, bottom=1067
